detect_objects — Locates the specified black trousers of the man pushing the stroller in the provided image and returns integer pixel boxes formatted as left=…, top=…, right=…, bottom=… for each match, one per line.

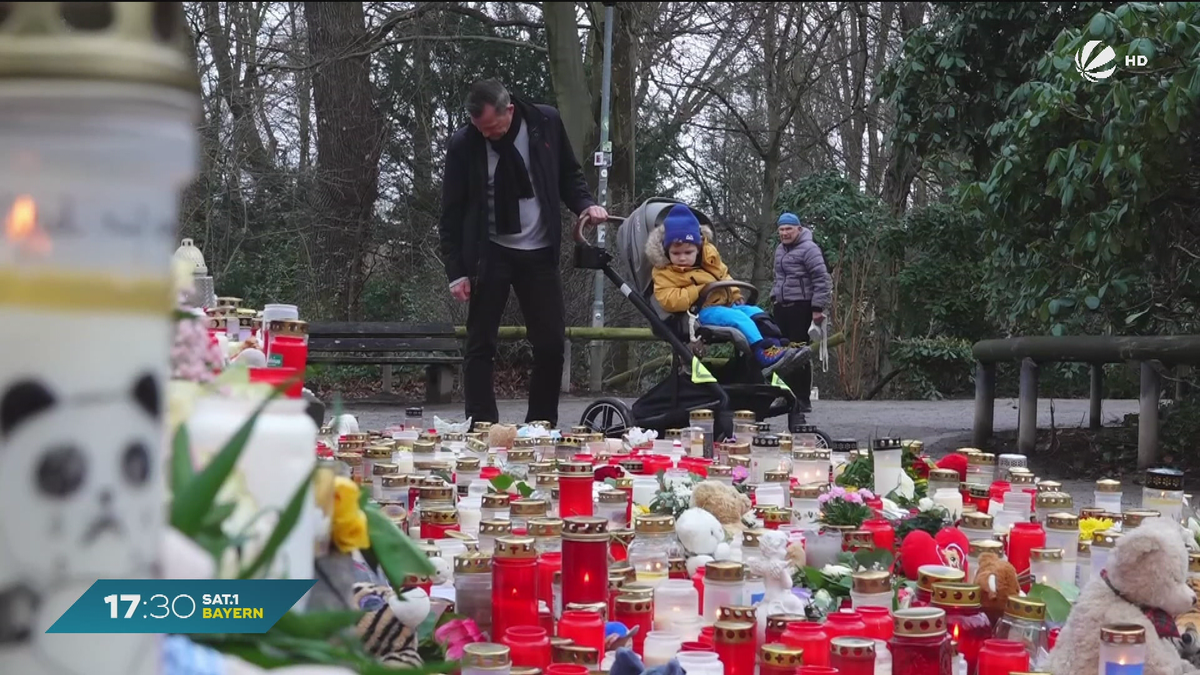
left=463, top=244, right=566, bottom=424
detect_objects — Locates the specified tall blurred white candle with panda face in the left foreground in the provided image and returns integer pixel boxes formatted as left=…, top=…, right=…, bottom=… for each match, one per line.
left=0, top=2, right=199, bottom=675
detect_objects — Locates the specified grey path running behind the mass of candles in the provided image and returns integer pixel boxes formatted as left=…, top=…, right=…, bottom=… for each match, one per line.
left=346, top=398, right=1141, bottom=509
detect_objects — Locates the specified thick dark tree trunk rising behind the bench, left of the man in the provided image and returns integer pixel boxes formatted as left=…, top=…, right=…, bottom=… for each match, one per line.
left=304, top=2, right=384, bottom=319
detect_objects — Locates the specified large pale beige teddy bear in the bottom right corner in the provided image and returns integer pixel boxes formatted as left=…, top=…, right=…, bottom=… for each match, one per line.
left=1046, top=518, right=1200, bottom=675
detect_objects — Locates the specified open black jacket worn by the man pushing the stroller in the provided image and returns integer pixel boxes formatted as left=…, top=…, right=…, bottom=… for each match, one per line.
left=438, top=97, right=595, bottom=282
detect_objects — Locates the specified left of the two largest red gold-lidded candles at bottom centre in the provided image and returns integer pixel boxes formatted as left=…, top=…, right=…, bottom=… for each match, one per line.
left=492, top=537, right=538, bottom=635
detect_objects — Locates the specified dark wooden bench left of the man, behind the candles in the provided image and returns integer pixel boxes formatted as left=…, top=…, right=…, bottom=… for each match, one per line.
left=308, top=322, right=462, bottom=404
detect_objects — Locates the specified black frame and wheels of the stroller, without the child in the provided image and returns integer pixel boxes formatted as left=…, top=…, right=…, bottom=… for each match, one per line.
left=574, top=197, right=828, bottom=442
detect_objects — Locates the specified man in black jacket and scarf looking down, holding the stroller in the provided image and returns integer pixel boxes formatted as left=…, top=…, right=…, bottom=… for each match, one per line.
left=438, top=80, right=608, bottom=424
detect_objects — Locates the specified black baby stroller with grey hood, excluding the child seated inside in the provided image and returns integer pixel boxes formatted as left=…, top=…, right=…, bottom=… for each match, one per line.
left=575, top=197, right=829, bottom=447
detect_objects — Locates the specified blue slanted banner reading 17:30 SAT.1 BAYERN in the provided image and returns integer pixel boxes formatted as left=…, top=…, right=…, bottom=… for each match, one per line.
left=46, top=579, right=317, bottom=633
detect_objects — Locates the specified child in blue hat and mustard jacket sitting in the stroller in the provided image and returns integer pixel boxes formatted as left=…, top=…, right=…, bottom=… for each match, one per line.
left=646, top=204, right=811, bottom=376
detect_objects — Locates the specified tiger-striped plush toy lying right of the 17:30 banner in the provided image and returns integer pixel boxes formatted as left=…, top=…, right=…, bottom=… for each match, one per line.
left=353, top=583, right=431, bottom=668
